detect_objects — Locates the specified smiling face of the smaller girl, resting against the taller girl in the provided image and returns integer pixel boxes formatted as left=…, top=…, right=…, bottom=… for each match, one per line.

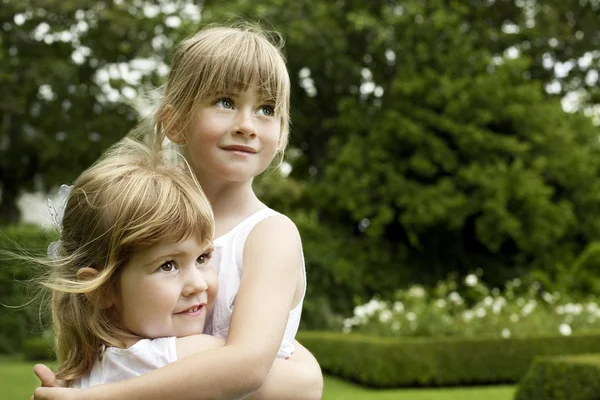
left=114, top=237, right=218, bottom=339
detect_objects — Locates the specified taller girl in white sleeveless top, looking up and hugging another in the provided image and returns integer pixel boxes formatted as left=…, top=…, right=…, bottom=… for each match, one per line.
left=35, top=27, right=322, bottom=400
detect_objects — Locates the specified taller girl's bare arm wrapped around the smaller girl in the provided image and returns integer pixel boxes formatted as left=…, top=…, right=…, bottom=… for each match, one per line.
left=36, top=216, right=302, bottom=400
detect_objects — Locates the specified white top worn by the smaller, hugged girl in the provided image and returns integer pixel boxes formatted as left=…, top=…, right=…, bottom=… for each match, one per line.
left=71, top=337, right=177, bottom=389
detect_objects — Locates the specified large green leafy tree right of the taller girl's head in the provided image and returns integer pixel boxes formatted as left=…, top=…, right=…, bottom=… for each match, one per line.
left=204, top=0, right=600, bottom=314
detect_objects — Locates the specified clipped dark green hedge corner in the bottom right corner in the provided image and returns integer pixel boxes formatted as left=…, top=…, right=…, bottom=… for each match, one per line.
left=515, top=354, right=600, bottom=400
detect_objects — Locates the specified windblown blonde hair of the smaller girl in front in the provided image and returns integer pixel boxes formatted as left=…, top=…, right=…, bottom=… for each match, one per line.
left=42, top=138, right=214, bottom=381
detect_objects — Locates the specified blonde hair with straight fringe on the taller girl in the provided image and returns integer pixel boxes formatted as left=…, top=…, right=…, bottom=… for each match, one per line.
left=134, top=23, right=290, bottom=160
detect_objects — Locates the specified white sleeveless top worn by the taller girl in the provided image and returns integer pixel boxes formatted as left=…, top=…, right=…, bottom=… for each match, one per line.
left=204, top=208, right=306, bottom=358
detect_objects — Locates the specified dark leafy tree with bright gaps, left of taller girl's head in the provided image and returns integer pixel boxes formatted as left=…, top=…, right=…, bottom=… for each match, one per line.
left=0, top=0, right=194, bottom=224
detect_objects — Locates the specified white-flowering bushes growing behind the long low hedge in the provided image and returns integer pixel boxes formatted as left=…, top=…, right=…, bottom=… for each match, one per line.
left=343, top=274, right=600, bottom=338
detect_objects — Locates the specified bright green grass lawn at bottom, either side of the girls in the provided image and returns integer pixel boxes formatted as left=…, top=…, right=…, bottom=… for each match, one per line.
left=0, top=358, right=515, bottom=400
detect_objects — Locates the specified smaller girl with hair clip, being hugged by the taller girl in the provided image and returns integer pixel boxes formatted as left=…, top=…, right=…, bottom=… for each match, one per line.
left=33, top=139, right=322, bottom=399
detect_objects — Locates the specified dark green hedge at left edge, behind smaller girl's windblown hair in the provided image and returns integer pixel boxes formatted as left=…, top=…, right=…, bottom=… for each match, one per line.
left=0, top=226, right=56, bottom=354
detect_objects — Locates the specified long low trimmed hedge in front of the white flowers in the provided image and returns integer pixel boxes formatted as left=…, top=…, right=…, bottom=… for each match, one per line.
left=297, top=331, right=600, bottom=388
